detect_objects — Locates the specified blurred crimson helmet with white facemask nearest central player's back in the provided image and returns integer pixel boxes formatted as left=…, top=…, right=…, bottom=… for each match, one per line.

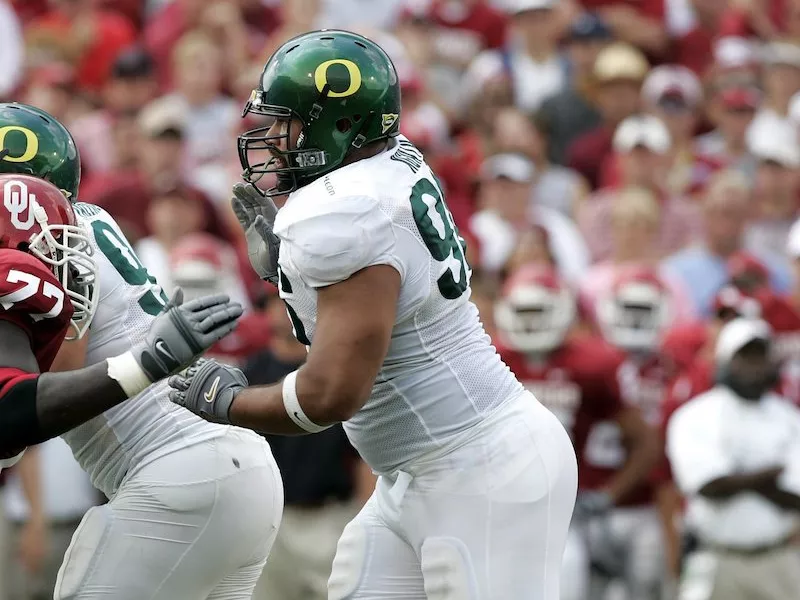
left=495, top=265, right=577, bottom=353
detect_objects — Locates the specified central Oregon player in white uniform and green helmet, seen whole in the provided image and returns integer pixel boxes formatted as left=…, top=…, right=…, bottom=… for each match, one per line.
left=170, top=31, right=577, bottom=600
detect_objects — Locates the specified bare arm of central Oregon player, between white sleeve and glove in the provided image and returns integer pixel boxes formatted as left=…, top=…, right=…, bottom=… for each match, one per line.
left=229, top=265, right=400, bottom=435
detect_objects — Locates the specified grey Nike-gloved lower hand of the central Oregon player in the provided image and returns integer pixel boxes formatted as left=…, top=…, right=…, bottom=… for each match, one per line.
left=169, top=358, right=248, bottom=423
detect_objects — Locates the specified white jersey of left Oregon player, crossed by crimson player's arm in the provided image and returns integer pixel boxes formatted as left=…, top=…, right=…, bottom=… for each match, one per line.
left=62, top=202, right=226, bottom=497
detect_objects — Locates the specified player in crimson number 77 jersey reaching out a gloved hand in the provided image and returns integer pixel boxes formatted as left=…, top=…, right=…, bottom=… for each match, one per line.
left=0, top=173, right=241, bottom=469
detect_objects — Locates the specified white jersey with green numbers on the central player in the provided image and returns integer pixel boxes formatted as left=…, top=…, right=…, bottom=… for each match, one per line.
left=274, top=136, right=524, bottom=472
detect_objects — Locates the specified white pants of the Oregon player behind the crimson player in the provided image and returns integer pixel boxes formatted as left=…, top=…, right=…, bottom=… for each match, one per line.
left=54, top=427, right=283, bottom=600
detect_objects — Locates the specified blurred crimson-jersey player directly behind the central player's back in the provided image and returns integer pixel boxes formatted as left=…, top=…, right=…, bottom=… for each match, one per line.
left=495, top=266, right=658, bottom=600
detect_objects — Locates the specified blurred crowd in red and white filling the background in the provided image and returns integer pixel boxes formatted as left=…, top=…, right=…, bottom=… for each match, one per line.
left=0, top=0, right=800, bottom=600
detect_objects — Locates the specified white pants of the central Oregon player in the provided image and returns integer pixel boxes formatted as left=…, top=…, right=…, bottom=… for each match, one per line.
left=328, top=394, right=578, bottom=600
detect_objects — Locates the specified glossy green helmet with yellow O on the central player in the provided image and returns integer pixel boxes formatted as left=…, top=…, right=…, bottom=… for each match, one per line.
left=238, top=29, right=400, bottom=196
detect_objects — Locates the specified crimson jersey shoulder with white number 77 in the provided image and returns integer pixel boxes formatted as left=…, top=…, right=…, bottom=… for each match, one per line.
left=0, top=248, right=72, bottom=372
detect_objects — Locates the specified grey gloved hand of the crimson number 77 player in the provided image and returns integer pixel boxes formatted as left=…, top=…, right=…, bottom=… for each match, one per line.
left=126, top=289, right=242, bottom=382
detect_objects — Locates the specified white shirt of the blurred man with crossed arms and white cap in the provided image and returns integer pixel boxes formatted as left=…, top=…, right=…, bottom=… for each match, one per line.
left=667, top=386, right=800, bottom=549
